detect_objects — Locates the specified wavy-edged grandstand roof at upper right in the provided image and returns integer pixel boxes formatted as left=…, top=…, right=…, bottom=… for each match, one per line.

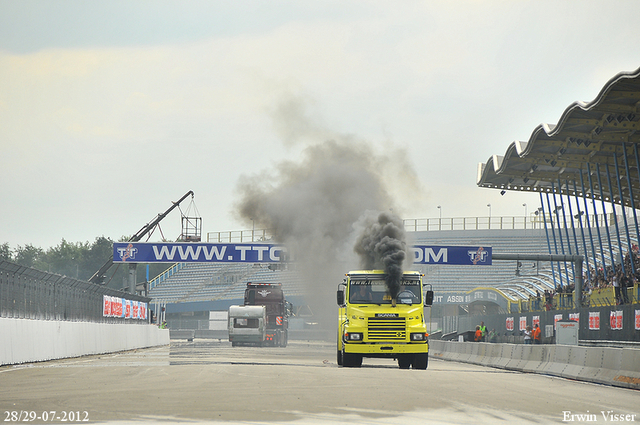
left=477, top=68, right=640, bottom=207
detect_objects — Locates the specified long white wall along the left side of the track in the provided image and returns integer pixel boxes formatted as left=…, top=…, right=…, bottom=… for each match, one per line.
left=0, top=318, right=169, bottom=365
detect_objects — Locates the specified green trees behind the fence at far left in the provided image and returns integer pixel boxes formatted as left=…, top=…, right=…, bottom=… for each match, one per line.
left=0, top=236, right=169, bottom=289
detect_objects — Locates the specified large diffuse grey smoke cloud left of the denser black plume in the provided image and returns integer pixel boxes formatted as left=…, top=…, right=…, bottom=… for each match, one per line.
left=237, top=140, right=391, bottom=329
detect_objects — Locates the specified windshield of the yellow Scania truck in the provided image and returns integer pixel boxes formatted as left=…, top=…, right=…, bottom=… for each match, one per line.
left=349, top=279, right=422, bottom=304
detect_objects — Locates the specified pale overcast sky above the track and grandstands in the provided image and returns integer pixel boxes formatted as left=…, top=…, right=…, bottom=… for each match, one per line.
left=0, top=0, right=640, bottom=248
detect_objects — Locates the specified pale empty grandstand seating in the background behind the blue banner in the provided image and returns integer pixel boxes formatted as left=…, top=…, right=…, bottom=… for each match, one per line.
left=149, top=217, right=553, bottom=303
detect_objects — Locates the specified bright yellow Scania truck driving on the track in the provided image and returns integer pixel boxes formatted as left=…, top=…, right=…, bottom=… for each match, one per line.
left=337, top=270, right=433, bottom=369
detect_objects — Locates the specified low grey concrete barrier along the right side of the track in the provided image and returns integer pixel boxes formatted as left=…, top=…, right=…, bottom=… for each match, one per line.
left=429, top=341, right=640, bottom=389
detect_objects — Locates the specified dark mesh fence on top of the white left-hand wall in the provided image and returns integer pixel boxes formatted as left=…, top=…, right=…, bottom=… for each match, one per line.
left=0, top=261, right=151, bottom=323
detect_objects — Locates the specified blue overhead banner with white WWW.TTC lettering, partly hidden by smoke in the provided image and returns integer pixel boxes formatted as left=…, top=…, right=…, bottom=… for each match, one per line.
left=113, top=242, right=491, bottom=265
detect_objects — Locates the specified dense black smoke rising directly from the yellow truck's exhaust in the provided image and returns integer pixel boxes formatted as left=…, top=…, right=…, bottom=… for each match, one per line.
left=354, top=212, right=407, bottom=300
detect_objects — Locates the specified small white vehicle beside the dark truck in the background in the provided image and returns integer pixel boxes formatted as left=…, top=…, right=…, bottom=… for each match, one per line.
left=229, top=305, right=267, bottom=347
